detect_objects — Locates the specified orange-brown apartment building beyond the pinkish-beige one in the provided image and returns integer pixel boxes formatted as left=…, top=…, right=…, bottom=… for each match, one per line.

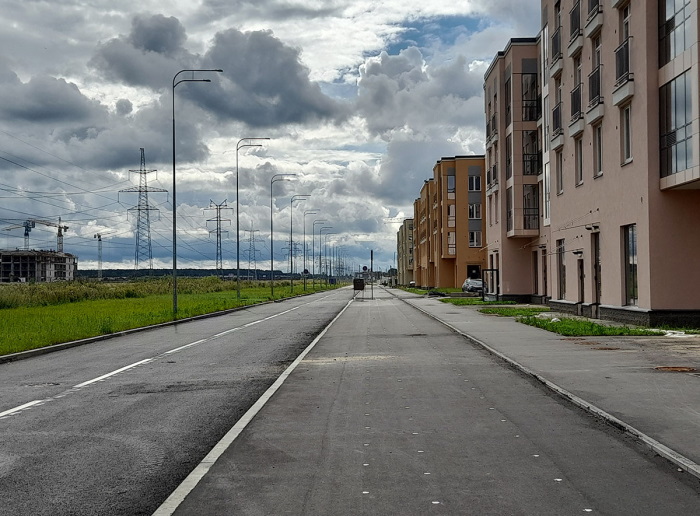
left=413, top=156, right=486, bottom=288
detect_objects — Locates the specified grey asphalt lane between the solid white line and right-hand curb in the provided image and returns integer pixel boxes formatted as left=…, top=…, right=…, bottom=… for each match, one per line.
left=175, top=289, right=700, bottom=516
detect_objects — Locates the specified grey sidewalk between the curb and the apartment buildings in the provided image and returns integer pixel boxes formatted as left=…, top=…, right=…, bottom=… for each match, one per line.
left=388, top=289, right=700, bottom=477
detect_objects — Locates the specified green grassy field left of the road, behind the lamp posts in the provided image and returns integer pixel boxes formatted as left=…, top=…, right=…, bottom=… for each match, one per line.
left=0, top=278, right=344, bottom=355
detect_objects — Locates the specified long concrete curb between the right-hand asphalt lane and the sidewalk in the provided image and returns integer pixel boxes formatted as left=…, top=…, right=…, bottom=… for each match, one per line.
left=391, top=293, right=700, bottom=479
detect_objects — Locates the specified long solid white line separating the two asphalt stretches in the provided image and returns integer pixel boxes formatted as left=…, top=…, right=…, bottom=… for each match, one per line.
left=153, top=299, right=353, bottom=516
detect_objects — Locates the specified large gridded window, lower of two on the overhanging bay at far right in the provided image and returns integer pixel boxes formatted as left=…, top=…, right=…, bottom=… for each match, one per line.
left=659, top=71, right=693, bottom=177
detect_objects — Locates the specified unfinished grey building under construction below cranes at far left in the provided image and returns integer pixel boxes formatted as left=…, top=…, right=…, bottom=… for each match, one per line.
left=0, top=249, right=78, bottom=283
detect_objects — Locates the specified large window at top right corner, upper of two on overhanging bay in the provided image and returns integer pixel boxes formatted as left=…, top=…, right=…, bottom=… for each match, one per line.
left=659, top=0, right=696, bottom=67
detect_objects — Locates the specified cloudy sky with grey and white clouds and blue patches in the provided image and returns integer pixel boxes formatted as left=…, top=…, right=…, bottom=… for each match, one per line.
left=0, top=0, right=540, bottom=271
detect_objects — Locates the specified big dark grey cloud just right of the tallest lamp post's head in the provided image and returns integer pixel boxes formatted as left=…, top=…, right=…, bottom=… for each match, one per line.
left=197, top=29, right=343, bottom=127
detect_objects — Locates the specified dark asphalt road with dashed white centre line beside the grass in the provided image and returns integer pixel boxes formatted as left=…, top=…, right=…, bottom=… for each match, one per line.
left=0, top=289, right=352, bottom=516
